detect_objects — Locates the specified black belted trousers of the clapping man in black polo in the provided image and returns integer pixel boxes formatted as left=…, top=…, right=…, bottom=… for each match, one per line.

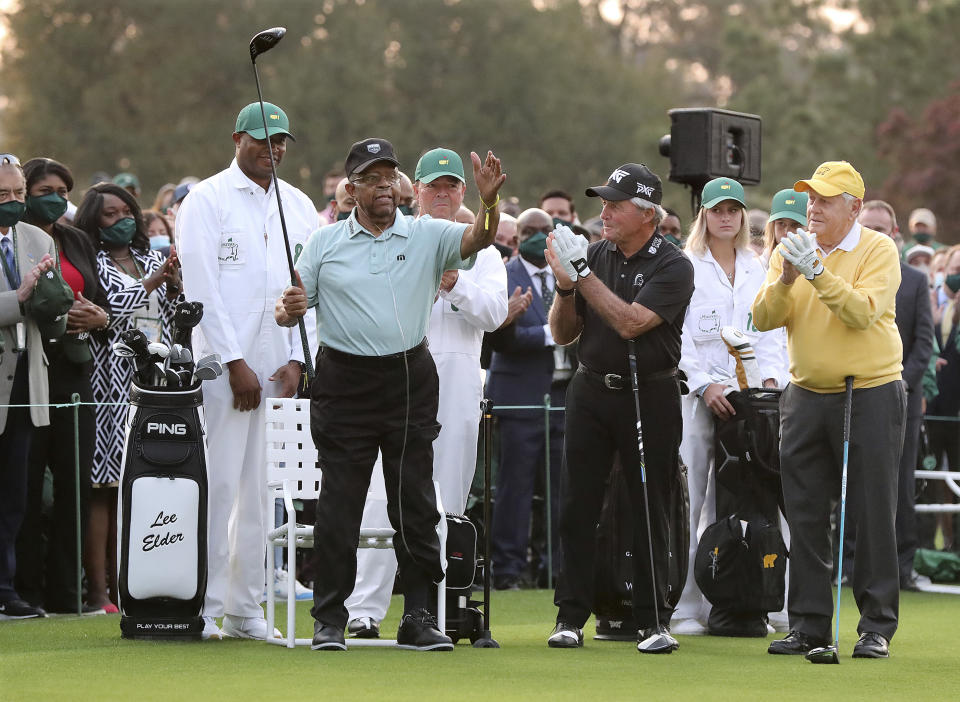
left=554, top=373, right=683, bottom=628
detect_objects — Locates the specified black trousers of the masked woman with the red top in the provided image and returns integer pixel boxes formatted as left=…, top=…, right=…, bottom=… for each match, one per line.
left=16, top=351, right=96, bottom=612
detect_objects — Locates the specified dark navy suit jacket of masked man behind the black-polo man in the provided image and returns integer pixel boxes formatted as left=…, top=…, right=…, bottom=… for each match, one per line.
left=487, top=257, right=553, bottom=405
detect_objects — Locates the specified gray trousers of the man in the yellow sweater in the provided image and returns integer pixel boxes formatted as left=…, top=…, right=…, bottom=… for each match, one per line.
left=780, top=380, right=906, bottom=642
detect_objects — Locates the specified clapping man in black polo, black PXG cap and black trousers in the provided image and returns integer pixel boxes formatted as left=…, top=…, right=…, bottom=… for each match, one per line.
left=546, top=163, right=693, bottom=651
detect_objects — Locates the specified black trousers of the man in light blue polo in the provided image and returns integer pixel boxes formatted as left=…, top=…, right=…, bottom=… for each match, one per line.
left=310, top=343, right=443, bottom=629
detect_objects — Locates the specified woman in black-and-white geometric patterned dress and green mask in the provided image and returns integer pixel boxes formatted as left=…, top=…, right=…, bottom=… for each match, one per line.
left=73, top=183, right=181, bottom=612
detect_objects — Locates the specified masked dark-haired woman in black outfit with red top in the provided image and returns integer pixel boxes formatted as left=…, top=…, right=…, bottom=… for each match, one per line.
left=17, top=158, right=110, bottom=612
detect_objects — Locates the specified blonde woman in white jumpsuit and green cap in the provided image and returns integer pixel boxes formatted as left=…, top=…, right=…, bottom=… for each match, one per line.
left=671, top=178, right=780, bottom=634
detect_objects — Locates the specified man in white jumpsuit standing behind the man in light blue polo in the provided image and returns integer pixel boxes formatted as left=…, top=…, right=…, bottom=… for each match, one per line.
left=346, top=148, right=507, bottom=638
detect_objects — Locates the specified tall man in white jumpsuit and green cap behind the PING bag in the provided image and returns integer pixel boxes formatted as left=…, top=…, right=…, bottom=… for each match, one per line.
left=176, top=102, right=319, bottom=639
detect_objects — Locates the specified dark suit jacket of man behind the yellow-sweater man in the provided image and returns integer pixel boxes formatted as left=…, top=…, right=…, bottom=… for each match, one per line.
left=897, top=263, right=933, bottom=417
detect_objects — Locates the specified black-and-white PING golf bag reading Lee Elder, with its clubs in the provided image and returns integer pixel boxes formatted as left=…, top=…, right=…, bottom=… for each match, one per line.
left=115, top=303, right=219, bottom=639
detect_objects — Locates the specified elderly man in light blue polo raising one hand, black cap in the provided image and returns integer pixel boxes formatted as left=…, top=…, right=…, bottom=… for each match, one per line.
left=275, top=139, right=506, bottom=650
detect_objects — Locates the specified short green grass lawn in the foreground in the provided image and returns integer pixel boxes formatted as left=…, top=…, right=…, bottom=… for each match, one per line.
left=0, top=590, right=960, bottom=702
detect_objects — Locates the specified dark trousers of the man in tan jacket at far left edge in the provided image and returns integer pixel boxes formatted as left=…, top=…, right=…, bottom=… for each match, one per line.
left=0, top=358, right=34, bottom=602
